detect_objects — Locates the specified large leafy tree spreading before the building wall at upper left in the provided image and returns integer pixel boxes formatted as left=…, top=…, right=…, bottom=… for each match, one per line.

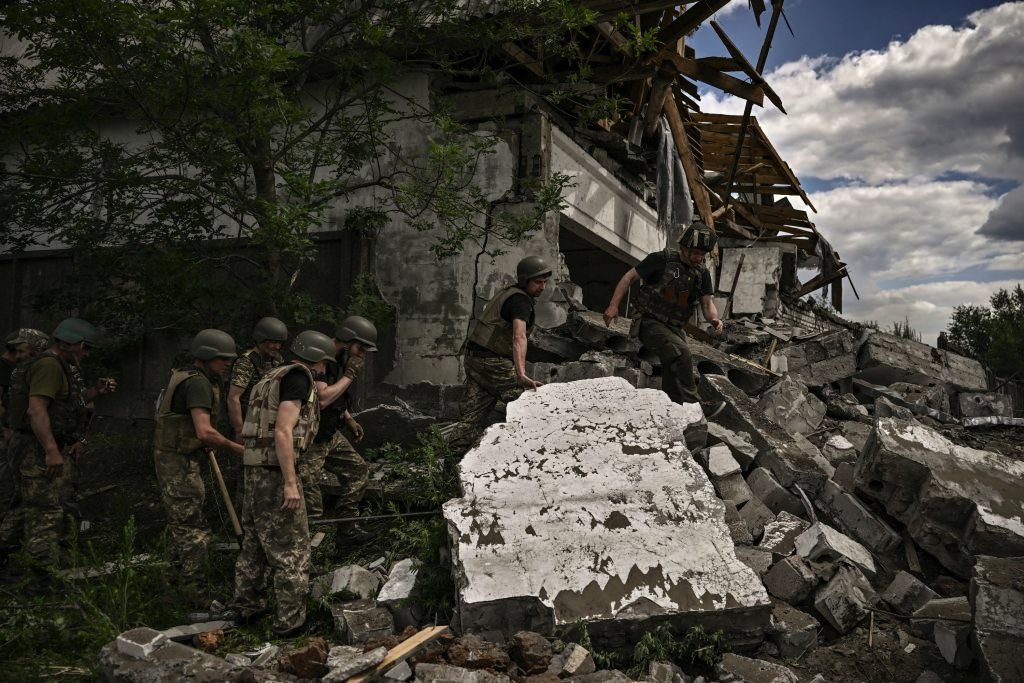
left=0, top=0, right=593, bottom=337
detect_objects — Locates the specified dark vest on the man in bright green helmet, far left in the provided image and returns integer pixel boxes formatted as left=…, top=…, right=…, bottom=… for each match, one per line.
left=7, top=351, right=89, bottom=447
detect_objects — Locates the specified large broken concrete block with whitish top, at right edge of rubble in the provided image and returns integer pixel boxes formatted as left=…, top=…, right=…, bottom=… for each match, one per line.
left=856, top=418, right=1024, bottom=577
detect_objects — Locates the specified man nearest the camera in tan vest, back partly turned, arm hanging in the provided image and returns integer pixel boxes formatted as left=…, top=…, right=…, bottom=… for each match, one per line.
left=232, top=330, right=334, bottom=637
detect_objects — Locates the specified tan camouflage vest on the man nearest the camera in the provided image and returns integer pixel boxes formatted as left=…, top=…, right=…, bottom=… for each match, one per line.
left=242, top=364, right=319, bottom=466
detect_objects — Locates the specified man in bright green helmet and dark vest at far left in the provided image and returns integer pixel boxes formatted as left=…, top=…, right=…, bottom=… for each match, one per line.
left=8, top=317, right=117, bottom=568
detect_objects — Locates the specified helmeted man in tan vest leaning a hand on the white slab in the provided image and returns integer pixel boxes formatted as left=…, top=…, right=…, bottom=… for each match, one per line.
left=447, top=256, right=551, bottom=449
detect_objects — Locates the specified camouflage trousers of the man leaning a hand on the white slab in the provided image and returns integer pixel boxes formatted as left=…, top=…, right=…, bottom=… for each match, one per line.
left=447, top=353, right=523, bottom=449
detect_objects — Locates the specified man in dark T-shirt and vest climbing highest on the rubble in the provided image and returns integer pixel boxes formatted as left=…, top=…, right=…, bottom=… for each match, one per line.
left=604, top=224, right=723, bottom=418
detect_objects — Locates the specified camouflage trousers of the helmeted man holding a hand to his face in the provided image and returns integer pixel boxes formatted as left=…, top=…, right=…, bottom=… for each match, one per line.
left=298, top=431, right=370, bottom=519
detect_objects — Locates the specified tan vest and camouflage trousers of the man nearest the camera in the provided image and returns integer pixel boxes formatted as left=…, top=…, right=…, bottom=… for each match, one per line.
left=232, top=365, right=319, bottom=633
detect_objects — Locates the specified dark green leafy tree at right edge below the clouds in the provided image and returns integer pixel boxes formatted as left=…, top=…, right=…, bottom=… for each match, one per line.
left=946, top=285, right=1024, bottom=378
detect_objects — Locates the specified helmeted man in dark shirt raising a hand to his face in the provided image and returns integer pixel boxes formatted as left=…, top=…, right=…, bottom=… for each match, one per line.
left=299, top=315, right=377, bottom=543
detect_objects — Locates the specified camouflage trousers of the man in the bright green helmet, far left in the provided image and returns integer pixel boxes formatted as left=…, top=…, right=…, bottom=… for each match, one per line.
left=3, top=432, right=77, bottom=566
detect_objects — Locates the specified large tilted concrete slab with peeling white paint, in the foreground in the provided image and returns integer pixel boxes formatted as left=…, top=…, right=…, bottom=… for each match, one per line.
left=444, top=378, right=771, bottom=647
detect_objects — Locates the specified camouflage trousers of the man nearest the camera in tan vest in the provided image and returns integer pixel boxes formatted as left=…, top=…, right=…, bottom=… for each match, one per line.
left=232, top=467, right=309, bottom=633
